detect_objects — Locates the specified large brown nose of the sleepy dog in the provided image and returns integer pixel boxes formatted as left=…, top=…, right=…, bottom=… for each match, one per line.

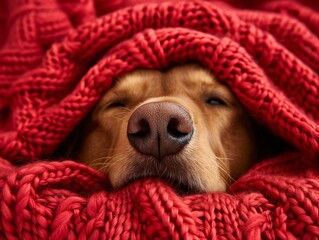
left=127, top=102, right=194, bottom=161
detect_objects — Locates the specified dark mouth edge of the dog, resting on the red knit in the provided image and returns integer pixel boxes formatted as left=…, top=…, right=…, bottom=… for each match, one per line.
left=123, top=175, right=202, bottom=196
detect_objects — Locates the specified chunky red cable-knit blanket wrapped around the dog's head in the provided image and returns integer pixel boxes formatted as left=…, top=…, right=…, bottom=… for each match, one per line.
left=0, top=0, right=319, bottom=240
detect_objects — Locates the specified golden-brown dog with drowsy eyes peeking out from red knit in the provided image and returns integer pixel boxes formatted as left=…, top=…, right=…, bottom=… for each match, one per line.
left=74, top=64, right=256, bottom=193
